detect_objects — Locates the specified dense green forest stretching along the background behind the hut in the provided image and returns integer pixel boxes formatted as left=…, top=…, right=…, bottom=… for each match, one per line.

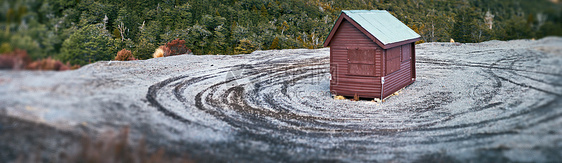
left=0, top=0, right=562, bottom=65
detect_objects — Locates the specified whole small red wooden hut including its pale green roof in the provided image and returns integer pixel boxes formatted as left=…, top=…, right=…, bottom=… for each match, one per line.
left=324, top=10, right=420, bottom=99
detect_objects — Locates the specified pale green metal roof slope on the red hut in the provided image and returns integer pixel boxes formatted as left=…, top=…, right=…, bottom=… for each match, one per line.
left=336, top=10, right=420, bottom=45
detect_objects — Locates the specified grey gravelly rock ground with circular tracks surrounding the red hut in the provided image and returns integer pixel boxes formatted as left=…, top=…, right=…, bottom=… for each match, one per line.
left=0, top=37, right=562, bottom=162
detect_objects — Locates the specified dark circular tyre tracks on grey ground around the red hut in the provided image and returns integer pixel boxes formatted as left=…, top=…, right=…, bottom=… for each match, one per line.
left=147, top=47, right=562, bottom=161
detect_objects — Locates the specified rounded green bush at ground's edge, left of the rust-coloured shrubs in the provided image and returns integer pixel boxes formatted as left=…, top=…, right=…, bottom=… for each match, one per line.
left=58, top=24, right=117, bottom=65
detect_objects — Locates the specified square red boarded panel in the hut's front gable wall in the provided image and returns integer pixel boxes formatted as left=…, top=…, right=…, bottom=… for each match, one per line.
left=347, top=48, right=375, bottom=76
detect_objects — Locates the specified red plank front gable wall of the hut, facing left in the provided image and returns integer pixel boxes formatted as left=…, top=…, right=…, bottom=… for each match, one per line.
left=330, top=19, right=383, bottom=98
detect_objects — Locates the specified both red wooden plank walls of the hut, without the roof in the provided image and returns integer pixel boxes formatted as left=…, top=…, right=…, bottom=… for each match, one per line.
left=329, top=16, right=415, bottom=98
